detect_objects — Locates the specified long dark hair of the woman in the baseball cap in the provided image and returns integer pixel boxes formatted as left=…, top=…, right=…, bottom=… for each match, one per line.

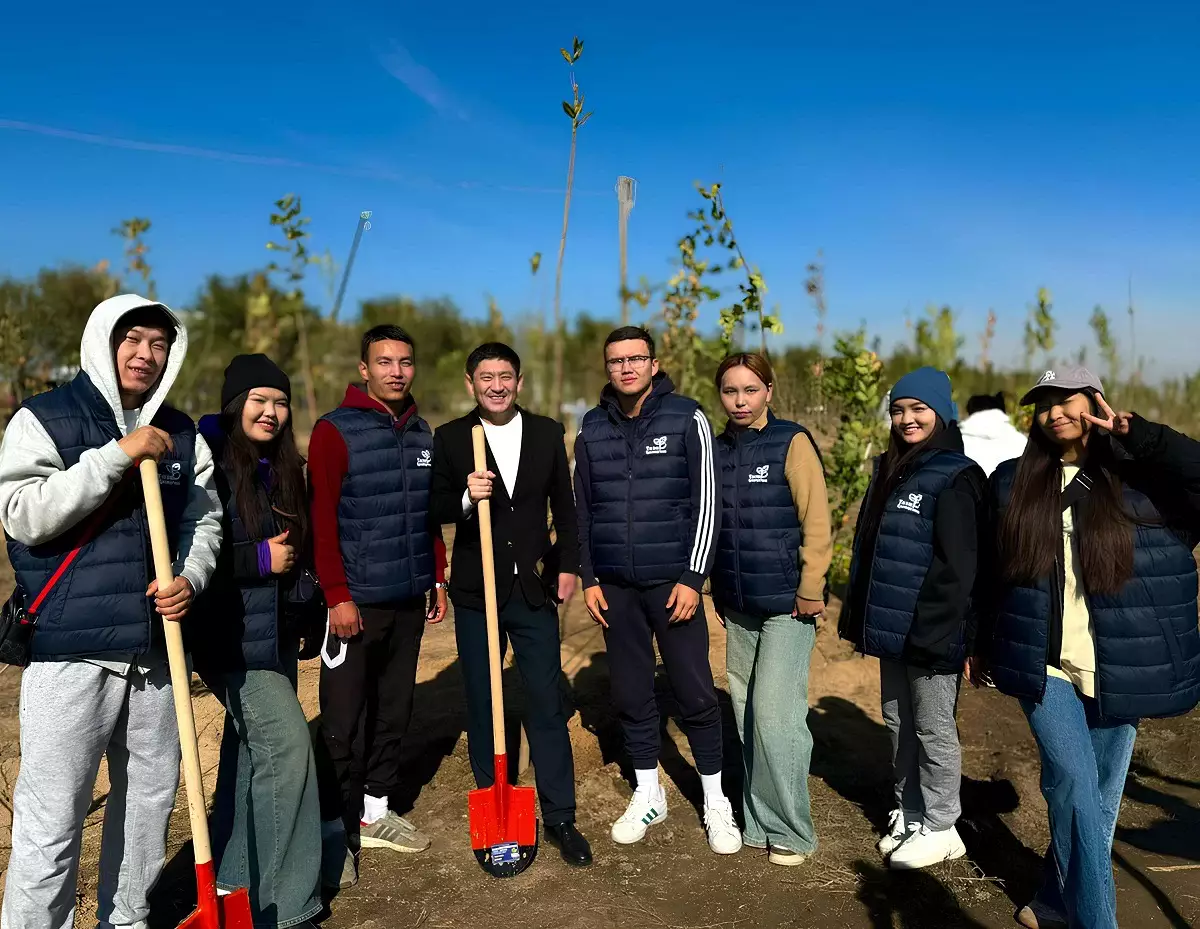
left=997, top=397, right=1134, bottom=594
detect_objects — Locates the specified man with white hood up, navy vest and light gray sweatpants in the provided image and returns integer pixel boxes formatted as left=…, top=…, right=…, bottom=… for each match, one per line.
left=0, top=294, right=221, bottom=929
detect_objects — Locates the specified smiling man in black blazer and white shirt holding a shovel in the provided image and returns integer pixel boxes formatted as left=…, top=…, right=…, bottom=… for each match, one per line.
left=432, top=342, right=592, bottom=865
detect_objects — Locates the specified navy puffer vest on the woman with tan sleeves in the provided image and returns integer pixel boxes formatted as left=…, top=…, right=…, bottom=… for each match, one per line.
left=712, top=413, right=809, bottom=616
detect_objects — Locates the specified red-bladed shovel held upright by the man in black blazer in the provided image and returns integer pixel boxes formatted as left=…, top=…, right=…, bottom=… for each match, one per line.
left=467, top=426, right=538, bottom=877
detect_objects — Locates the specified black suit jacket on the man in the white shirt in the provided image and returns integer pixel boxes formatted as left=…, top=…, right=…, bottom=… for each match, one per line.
left=431, top=409, right=580, bottom=610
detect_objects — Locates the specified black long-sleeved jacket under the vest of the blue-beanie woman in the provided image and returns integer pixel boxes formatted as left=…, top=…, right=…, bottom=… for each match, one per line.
left=839, top=422, right=988, bottom=673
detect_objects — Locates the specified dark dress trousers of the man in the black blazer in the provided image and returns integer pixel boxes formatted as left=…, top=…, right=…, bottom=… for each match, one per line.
left=454, top=600, right=575, bottom=826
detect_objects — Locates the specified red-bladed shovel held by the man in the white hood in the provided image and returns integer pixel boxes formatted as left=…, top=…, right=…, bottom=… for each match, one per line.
left=138, top=458, right=253, bottom=929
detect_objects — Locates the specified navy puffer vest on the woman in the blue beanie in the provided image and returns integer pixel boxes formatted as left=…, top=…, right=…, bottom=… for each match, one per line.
left=850, top=449, right=978, bottom=663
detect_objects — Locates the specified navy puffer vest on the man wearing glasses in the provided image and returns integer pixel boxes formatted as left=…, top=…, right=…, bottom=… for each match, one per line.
left=576, top=376, right=703, bottom=586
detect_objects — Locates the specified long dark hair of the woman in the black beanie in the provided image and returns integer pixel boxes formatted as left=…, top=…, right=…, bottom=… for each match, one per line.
left=221, top=390, right=308, bottom=551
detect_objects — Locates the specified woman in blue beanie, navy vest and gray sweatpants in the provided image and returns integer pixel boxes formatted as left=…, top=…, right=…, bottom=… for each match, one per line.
left=838, top=367, right=986, bottom=870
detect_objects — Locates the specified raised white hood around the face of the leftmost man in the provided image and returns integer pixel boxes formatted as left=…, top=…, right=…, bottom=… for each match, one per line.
left=79, top=294, right=187, bottom=436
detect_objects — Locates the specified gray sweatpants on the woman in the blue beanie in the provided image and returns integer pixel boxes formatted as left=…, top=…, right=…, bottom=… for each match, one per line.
left=880, top=660, right=962, bottom=832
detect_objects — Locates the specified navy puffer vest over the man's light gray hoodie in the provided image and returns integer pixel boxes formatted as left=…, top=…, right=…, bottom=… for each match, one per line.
left=8, top=372, right=196, bottom=661
